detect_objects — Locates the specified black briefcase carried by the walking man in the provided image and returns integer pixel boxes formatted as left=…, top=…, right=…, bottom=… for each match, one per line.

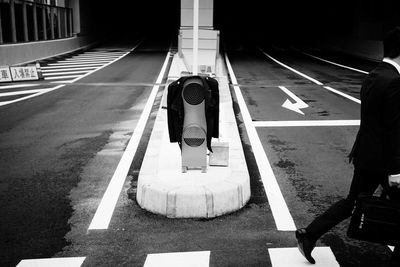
left=347, top=196, right=400, bottom=245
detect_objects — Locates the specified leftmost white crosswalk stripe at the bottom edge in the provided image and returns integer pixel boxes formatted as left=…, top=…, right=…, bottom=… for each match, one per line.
left=17, top=257, right=86, bottom=267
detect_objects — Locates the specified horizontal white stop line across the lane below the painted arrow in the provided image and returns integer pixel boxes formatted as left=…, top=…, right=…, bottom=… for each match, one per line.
left=253, top=120, right=360, bottom=127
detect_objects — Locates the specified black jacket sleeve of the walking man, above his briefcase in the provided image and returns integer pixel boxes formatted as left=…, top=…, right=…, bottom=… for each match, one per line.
left=383, top=78, right=400, bottom=174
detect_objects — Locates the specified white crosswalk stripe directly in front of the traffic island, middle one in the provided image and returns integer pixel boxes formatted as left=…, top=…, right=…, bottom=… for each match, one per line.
left=143, top=251, right=210, bottom=267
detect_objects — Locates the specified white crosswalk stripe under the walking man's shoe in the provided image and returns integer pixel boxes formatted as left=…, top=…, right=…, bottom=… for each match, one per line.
left=268, top=247, right=339, bottom=267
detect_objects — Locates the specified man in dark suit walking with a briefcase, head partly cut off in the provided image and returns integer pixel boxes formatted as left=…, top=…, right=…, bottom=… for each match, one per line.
left=296, top=27, right=400, bottom=267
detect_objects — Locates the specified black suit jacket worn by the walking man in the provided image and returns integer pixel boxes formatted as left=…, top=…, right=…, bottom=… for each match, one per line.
left=350, top=62, right=400, bottom=175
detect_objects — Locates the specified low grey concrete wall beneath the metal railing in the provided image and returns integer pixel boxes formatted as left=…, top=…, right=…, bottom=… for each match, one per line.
left=0, top=37, right=92, bottom=66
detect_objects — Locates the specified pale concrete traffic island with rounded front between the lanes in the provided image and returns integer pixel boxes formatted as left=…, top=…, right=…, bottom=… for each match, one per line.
left=136, top=55, right=250, bottom=218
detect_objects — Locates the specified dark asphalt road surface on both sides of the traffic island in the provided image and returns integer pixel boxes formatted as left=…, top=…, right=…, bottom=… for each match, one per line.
left=0, top=36, right=390, bottom=267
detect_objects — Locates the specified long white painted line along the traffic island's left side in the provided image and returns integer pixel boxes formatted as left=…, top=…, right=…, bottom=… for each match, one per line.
left=88, top=52, right=171, bottom=230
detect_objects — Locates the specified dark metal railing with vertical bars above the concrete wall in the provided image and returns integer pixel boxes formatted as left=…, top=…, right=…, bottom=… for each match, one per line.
left=0, top=0, right=73, bottom=44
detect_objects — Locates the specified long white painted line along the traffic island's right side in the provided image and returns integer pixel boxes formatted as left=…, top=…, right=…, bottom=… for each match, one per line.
left=225, top=54, right=296, bottom=231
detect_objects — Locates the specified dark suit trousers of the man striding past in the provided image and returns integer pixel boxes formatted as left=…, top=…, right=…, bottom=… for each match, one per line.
left=306, top=167, right=400, bottom=261
